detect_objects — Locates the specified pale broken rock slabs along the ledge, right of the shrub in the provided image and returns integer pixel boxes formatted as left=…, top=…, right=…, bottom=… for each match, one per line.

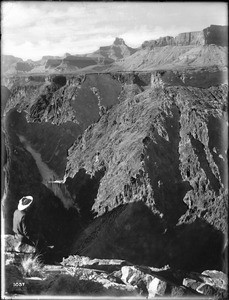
left=61, top=255, right=227, bottom=299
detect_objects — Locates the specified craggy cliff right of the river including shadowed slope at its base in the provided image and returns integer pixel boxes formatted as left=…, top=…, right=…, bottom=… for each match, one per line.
left=66, top=84, right=227, bottom=270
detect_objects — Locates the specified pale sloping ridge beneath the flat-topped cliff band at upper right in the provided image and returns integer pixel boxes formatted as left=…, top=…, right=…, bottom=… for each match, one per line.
left=114, top=45, right=227, bottom=71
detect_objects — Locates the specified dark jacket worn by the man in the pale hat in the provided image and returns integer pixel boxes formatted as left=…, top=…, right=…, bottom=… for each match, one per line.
left=13, top=210, right=31, bottom=244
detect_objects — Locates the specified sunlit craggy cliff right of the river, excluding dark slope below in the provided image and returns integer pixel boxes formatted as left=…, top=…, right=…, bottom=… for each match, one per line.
left=67, top=86, right=227, bottom=229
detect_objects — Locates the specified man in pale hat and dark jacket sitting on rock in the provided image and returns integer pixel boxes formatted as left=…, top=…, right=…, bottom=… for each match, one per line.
left=13, top=196, right=36, bottom=253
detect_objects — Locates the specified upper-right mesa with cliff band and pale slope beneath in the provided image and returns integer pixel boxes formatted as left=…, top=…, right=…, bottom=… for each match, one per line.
left=112, top=25, right=228, bottom=71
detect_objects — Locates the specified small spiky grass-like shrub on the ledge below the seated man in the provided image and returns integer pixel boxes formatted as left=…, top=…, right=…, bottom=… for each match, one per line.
left=21, top=254, right=43, bottom=277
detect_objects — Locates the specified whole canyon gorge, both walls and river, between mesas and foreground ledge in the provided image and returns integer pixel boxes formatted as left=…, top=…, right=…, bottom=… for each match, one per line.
left=2, top=70, right=227, bottom=271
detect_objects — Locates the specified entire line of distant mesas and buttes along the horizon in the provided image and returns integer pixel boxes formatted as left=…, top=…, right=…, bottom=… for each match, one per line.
left=2, top=25, right=228, bottom=76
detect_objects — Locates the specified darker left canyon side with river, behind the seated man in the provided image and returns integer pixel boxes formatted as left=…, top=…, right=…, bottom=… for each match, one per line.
left=2, top=74, right=135, bottom=245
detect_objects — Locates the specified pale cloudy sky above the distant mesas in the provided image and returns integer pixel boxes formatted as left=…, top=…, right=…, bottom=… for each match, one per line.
left=1, top=1, right=227, bottom=60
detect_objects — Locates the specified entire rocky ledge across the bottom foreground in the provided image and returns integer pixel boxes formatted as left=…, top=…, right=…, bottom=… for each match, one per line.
left=5, top=248, right=227, bottom=299
